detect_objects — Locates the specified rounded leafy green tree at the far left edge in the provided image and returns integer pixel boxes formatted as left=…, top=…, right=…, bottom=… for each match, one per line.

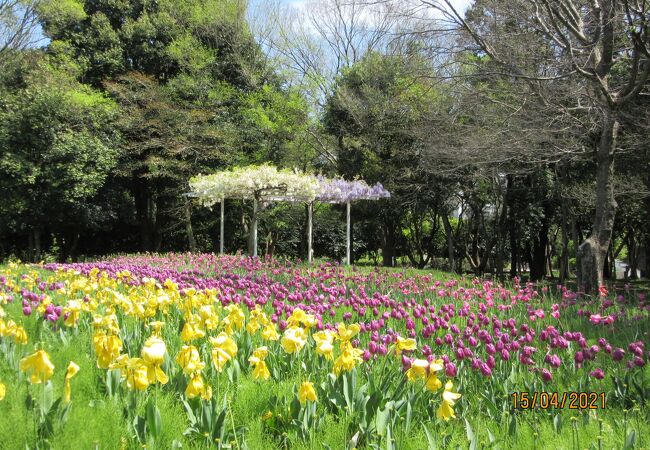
left=0, top=57, right=117, bottom=260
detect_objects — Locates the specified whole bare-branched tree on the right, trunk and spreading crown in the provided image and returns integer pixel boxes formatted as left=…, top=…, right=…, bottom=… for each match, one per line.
left=400, top=0, right=650, bottom=294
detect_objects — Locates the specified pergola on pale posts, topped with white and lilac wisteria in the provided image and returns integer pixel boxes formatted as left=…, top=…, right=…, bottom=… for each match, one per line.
left=188, top=164, right=390, bottom=264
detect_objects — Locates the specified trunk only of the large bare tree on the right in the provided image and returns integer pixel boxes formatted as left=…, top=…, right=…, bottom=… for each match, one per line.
left=577, top=110, right=619, bottom=295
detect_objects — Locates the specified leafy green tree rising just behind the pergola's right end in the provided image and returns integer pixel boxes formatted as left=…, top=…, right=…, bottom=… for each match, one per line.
left=324, top=53, right=444, bottom=266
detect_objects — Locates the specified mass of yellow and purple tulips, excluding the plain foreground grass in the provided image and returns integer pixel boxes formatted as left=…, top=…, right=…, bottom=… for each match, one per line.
left=0, top=254, right=650, bottom=446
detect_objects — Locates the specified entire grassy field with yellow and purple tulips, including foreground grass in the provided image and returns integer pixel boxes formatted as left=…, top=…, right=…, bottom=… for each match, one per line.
left=0, top=254, right=650, bottom=449
